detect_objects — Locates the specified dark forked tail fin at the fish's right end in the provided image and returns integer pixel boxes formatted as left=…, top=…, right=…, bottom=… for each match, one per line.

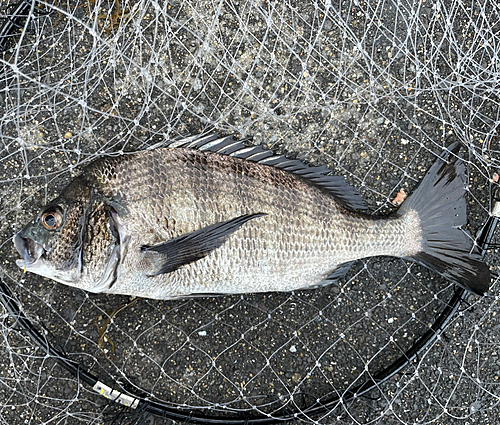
left=397, top=143, right=491, bottom=295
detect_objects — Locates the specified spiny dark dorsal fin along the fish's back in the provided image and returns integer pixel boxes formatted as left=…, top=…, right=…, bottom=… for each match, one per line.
left=168, top=133, right=368, bottom=211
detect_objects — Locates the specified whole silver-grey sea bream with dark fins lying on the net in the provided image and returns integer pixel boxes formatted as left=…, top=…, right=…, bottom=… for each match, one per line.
left=13, top=134, right=491, bottom=299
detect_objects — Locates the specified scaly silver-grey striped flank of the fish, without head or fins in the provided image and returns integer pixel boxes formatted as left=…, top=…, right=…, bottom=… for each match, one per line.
left=87, top=149, right=418, bottom=298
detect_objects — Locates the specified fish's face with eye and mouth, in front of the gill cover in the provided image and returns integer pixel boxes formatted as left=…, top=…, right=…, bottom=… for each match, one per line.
left=13, top=178, right=90, bottom=286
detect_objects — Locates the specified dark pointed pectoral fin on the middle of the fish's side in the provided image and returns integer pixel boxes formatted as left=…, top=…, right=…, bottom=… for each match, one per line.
left=141, top=213, right=266, bottom=276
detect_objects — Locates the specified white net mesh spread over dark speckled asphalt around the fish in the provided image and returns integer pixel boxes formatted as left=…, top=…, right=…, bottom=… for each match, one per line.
left=0, top=0, right=500, bottom=425
